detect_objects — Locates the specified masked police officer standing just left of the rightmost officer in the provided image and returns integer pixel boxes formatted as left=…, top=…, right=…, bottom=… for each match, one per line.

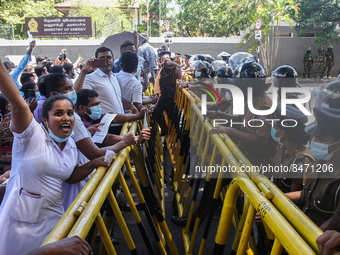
left=271, top=104, right=315, bottom=193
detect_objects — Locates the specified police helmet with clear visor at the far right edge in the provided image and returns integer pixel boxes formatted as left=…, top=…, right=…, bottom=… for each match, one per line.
left=309, top=79, right=340, bottom=109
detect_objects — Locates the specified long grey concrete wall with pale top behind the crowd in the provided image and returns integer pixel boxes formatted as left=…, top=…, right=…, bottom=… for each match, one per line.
left=0, top=26, right=340, bottom=76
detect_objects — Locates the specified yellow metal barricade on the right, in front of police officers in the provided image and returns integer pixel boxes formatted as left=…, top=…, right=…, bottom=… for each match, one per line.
left=167, top=86, right=340, bottom=254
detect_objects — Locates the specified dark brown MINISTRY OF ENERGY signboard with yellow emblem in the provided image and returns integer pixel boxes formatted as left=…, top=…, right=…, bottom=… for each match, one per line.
left=25, top=17, right=92, bottom=38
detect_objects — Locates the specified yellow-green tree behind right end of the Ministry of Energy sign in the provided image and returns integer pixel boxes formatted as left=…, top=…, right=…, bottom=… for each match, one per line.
left=71, top=0, right=132, bottom=37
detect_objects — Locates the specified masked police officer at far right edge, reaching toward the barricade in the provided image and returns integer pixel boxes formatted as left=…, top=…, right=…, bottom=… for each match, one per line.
left=286, top=105, right=340, bottom=226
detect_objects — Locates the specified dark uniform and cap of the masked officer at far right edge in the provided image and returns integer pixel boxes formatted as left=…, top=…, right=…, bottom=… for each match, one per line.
left=303, top=106, right=340, bottom=226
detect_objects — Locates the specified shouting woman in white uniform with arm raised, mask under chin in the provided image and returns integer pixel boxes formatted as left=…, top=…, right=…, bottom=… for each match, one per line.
left=0, top=60, right=107, bottom=254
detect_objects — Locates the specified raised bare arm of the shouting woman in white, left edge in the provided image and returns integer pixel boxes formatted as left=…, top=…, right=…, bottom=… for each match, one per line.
left=0, top=60, right=33, bottom=133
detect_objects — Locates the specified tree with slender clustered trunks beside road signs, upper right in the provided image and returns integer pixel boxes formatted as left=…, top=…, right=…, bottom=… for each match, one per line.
left=238, top=0, right=298, bottom=74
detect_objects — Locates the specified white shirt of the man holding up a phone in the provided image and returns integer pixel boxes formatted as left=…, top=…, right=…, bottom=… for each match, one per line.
left=84, top=68, right=124, bottom=114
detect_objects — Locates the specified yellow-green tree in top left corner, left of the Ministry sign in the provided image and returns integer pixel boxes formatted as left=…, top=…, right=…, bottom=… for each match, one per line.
left=0, top=0, right=63, bottom=39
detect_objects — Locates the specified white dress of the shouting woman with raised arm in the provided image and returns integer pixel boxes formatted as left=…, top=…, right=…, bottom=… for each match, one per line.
left=0, top=118, right=78, bottom=254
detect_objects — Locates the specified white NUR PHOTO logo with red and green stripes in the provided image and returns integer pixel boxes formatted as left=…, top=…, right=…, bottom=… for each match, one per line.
left=201, top=84, right=312, bottom=127
